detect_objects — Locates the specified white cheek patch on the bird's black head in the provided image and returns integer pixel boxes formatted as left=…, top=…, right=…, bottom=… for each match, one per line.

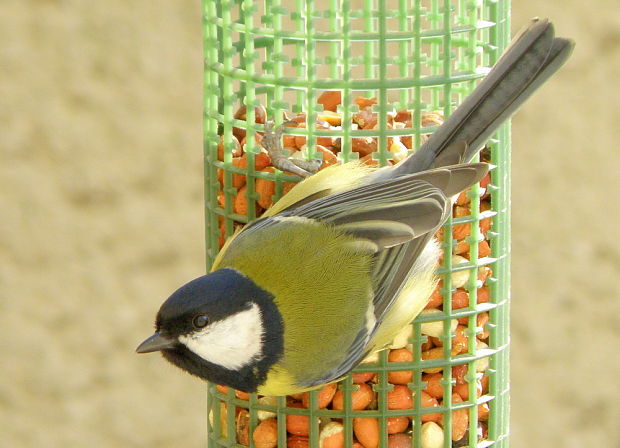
left=179, top=304, right=264, bottom=370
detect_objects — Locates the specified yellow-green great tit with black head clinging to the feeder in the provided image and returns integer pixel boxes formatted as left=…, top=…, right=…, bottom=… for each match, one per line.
left=136, top=18, right=574, bottom=396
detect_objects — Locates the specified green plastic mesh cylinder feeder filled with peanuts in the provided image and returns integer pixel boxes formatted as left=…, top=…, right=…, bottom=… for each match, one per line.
left=202, top=0, right=510, bottom=448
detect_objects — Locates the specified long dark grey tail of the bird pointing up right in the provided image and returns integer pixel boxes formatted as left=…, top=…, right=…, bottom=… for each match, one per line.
left=392, top=19, right=574, bottom=176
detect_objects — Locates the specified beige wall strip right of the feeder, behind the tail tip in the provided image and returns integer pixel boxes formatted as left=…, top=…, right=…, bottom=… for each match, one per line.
left=511, top=0, right=620, bottom=448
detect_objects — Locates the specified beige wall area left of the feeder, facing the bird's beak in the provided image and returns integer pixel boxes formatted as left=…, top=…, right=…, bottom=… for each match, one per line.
left=0, top=0, right=205, bottom=447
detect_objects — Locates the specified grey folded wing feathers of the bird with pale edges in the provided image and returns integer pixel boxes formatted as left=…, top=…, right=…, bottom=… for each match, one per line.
left=278, top=163, right=488, bottom=386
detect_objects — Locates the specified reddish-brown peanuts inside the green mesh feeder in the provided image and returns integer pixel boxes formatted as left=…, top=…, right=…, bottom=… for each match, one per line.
left=210, top=91, right=492, bottom=448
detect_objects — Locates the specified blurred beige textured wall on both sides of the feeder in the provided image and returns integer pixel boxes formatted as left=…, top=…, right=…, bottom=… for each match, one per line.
left=0, top=0, right=620, bottom=448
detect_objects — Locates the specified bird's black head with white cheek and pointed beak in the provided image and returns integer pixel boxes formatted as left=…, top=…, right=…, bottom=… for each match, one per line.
left=136, top=268, right=283, bottom=392
